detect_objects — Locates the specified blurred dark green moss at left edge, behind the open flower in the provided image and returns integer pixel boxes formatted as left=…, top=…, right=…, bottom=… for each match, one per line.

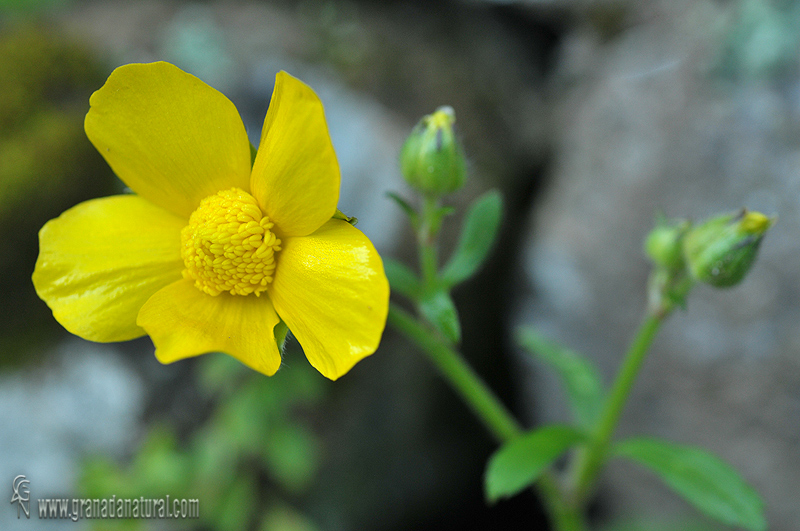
left=0, top=23, right=119, bottom=364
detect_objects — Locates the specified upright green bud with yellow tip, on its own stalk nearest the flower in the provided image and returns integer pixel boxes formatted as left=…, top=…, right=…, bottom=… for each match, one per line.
left=400, top=106, right=467, bottom=196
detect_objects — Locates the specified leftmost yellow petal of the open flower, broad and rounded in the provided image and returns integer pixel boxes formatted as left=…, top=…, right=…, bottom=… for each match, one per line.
left=33, top=195, right=186, bottom=341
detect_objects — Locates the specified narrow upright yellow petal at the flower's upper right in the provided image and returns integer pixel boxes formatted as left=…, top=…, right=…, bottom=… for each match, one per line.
left=250, top=72, right=341, bottom=237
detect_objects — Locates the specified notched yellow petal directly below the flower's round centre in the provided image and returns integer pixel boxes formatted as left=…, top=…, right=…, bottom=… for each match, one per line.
left=138, top=279, right=281, bottom=376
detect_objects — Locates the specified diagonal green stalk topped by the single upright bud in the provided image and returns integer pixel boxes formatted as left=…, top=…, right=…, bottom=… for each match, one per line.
left=387, top=109, right=586, bottom=531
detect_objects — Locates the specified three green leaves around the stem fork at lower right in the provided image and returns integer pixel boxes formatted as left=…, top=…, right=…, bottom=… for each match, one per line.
left=485, top=328, right=767, bottom=531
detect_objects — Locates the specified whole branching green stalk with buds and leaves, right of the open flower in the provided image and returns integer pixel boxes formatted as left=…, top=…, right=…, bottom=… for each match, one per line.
left=388, top=108, right=774, bottom=531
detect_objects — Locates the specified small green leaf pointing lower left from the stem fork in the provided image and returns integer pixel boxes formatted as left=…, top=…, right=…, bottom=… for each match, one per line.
left=484, top=425, right=586, bottom=502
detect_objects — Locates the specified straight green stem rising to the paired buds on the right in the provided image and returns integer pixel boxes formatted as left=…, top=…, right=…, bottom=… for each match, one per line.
left=573, top=312, right=669, bottom=505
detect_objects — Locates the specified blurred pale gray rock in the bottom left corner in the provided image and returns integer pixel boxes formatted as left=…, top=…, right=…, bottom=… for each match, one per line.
left=0, top=338, right=144, bottom=529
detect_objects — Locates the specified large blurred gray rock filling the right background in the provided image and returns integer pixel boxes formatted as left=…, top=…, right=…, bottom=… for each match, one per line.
left=519, top=2, right=800, bottom=530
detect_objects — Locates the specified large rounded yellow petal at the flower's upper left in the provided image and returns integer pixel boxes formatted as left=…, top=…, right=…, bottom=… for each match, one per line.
left=85, top=62, right=250, bottom=218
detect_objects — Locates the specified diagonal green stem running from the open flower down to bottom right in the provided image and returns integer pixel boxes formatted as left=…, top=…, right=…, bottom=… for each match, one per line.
left=388, top=304, right=586, bottom=531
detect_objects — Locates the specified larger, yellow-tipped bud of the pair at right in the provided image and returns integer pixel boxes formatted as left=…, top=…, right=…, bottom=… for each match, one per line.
left=683, top=210, right=774, bottom=287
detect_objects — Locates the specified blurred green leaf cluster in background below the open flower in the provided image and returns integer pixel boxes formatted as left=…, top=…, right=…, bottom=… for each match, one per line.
left=81, top=355, right=322, bottom=531
